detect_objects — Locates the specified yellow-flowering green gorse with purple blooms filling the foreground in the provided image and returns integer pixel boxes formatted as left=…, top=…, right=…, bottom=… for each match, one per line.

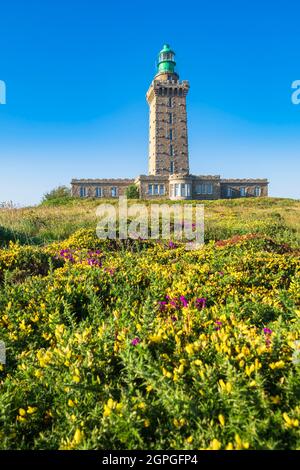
left=0, top=226, right=300, bottom=450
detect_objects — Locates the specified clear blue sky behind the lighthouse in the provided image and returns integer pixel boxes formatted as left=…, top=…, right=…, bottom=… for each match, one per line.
left=0, top=0, right=300, bottom=204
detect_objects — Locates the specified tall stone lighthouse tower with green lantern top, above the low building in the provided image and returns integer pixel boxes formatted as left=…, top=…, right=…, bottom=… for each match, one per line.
left=147, top=44, right=189, bottom=176
